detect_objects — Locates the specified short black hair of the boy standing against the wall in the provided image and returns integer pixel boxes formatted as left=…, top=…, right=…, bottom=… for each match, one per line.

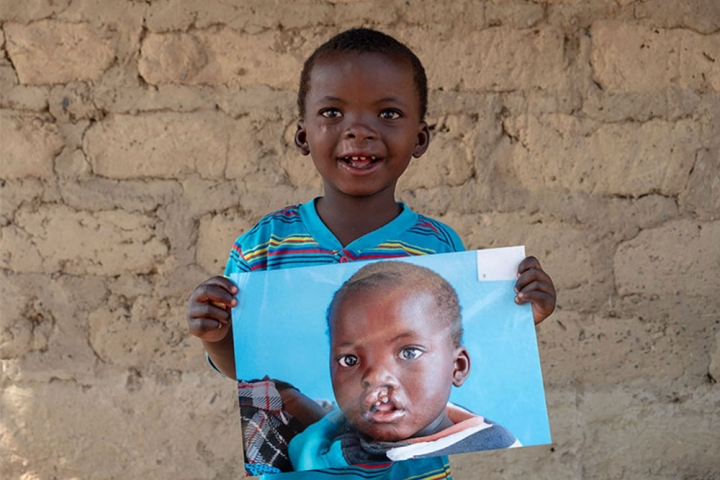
left=297, top=28, right=428, bottom=120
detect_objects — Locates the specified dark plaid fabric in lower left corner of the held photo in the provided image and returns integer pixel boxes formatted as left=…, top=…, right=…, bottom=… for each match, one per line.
left=238, top=378, right=302, bottom=475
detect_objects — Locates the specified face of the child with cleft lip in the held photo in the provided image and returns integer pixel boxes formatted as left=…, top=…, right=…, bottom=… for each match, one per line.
left=330, top=286, right=470, bottom=441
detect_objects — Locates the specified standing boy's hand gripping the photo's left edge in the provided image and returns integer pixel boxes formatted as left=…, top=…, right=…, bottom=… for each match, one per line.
left=187, top=277, right=238, bottom=342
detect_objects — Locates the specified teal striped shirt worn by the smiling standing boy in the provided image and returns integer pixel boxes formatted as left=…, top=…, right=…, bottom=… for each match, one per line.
left=225, top=200, right=465, bottom=480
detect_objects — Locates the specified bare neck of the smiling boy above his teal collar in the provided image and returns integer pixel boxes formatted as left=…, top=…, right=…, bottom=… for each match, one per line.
left=315, top=190, right=402, bottom=247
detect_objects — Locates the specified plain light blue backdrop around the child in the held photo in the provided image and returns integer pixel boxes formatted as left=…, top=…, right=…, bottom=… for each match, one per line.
left=231, top=251, right=550, bottom=446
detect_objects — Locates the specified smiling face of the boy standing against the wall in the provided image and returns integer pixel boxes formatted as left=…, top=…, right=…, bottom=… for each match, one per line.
left=295, top=52, right=430, bottom=201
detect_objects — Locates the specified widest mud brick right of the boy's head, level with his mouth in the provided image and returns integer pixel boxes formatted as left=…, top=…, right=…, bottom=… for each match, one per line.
left=506, top=115, right=701, bottom=197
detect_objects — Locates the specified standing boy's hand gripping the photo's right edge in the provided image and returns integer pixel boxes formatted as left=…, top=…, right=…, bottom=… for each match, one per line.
left=515, top=257, right=556, bottom=325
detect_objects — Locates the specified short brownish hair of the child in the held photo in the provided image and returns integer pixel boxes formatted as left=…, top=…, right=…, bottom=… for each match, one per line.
left=327, top=260, right=463, bottom=347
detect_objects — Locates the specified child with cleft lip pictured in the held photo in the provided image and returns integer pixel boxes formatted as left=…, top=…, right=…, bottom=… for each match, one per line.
left=289, top=261, right=520, bottom=470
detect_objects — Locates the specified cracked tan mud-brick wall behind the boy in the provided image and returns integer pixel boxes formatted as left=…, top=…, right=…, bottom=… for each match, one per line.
left=0, top=0, right=720, bottom=480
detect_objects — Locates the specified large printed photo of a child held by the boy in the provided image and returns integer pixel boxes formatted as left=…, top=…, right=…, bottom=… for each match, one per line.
left=233, top=249, right=550, bottom=474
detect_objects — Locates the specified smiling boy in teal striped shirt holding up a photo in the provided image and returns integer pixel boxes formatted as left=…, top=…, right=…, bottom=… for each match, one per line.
left=187, top=29, right=555, bottom=479
